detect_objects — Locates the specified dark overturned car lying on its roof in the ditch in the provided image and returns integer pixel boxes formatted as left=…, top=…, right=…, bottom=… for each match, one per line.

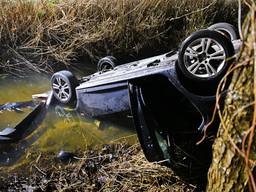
left=51, top=23, right=241, bottom=182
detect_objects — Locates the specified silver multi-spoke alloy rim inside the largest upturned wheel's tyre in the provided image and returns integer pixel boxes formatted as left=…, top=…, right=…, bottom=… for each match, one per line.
left=183, top=38, right=226, bottom=78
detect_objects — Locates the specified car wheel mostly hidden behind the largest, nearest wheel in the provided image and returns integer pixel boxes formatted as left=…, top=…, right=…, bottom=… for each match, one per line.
left=208, top=23, right=239, bottom=41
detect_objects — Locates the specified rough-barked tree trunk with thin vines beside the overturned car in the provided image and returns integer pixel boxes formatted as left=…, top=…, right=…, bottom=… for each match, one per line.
left=207, top=3, right=256, bottom=192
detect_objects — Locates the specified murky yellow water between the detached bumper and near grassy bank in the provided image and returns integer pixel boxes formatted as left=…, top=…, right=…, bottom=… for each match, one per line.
left=0, top=103, right=136, bottom=166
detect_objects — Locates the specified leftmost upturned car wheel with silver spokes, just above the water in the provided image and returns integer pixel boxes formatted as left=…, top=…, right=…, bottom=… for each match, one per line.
left=51, top=70, right=78, bottom=104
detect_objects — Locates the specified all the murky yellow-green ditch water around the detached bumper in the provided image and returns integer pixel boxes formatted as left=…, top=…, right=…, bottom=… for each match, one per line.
left=0, top=76, right=136, bottom=169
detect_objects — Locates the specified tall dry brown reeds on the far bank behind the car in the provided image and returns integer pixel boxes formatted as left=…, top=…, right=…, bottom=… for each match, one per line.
left=0, top=0, right=237, bottom=74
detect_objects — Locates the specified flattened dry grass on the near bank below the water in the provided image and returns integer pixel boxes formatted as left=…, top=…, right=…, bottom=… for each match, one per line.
left=0, top=143, right=196, bottom=192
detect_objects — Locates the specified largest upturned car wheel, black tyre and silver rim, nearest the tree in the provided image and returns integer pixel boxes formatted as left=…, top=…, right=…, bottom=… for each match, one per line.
left=177, top=30, right=235, bottom=83
